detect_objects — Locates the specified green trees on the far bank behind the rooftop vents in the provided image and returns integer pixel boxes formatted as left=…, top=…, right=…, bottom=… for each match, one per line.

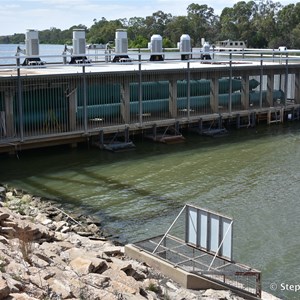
left=0, top=0, right=300, bottom=48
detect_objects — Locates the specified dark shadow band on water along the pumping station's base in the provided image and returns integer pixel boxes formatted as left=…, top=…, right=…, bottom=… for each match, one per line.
left=0, top=123, right=300, bottom=178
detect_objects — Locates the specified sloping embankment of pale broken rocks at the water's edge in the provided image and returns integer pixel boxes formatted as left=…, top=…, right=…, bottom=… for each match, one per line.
left=0, top=186, right=247, bottom=300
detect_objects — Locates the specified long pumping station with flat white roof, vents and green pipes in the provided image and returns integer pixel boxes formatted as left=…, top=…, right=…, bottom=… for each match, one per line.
left=0, top=29, right=300, bottom=153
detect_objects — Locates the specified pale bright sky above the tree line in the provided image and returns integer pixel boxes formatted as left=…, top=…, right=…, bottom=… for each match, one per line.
left=0, top=0, right=297, bottom=36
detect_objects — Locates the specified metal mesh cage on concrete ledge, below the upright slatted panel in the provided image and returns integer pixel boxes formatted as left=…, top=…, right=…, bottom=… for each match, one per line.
left=134, top=214, right=262, bottom=298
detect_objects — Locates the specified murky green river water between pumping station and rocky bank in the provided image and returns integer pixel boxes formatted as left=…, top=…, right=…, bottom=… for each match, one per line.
left=0, top=123, right=300, bottom=299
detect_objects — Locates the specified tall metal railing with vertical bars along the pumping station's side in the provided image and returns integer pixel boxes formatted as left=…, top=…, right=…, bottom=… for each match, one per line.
left=0, top=50, right=300, bottom=144
